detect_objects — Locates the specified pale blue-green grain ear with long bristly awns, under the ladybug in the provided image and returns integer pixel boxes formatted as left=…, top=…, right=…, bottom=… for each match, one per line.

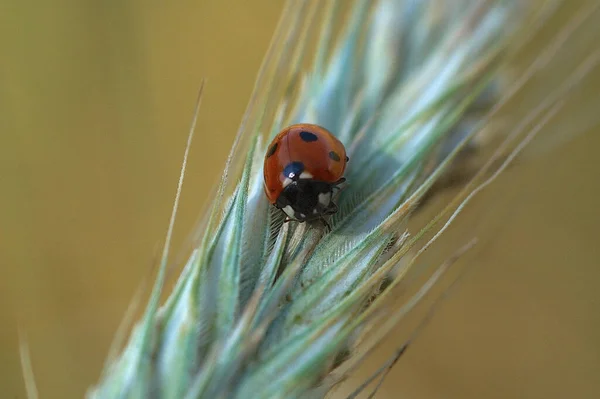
left=78, top=0, right=596, bottom=398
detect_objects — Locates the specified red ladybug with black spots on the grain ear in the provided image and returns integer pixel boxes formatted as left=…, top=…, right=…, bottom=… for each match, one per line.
left=263, top=123, right=349, bottom=225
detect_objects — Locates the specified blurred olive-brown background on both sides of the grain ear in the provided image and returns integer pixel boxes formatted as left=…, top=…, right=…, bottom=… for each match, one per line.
left=0, top=0, right=600, bottom=398
